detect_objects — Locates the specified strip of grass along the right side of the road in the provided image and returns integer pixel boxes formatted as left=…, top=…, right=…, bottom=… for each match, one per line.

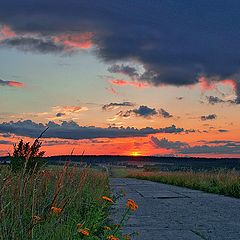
left=127, top=171, right=240, bottom=198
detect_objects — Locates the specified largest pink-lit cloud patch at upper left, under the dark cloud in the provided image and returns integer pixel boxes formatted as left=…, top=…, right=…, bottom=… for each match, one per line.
left=53, top=32, right=93, bottom=49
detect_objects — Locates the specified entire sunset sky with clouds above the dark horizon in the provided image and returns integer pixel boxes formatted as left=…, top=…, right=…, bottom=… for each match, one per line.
left=0, top=0, right=240, bottom=157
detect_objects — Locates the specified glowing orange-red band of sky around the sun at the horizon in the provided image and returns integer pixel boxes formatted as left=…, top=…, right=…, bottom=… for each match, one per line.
left=0, top=134, right=240, bottom=157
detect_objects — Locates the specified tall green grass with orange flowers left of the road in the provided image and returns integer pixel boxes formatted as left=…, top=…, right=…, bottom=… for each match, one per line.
left=0, top=165, right=136, bottom=240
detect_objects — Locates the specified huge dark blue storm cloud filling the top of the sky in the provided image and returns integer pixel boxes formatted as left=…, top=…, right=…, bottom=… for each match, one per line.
left=0, top=0, right=240, bottom=103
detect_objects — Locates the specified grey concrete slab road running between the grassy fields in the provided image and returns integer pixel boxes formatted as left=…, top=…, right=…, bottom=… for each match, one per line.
left=110, top=178, right=240, bottom=240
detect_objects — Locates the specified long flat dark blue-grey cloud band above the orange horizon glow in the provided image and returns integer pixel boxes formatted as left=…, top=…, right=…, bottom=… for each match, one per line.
left=0, top=120, right=187, bottom=140
